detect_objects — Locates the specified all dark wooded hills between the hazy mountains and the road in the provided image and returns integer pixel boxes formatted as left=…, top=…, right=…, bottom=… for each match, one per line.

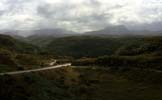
left=0, top=35, right=162, bottom=70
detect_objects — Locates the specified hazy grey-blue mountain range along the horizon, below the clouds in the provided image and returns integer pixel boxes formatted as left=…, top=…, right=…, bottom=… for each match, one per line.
left=0, top=25, right=162, bottom=39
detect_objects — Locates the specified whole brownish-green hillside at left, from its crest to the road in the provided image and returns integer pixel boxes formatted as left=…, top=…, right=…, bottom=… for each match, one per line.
left=0, top=35, right=49, bottom=72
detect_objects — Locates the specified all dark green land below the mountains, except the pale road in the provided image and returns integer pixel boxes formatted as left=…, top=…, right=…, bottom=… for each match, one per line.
left=0, top=35, right=162, bottom=100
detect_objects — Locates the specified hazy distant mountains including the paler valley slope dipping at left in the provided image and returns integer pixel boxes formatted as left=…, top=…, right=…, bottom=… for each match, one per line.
left=0, top=25, right=162, bottom=47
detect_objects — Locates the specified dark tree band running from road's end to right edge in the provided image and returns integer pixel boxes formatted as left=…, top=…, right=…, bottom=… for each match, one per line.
left=72, top=56, right=162, bottom=70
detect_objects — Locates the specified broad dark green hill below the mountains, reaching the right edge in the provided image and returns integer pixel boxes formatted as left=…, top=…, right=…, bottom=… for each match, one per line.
left=46, top=36, right=162, bottom=57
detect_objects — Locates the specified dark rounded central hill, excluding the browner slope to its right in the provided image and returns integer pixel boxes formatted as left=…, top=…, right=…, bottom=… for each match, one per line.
left=46, top=36, right=138, bottom=57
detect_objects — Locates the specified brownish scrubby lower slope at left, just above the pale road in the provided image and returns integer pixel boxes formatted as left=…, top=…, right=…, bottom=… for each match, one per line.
left=0, top=49, right=48, bottom=72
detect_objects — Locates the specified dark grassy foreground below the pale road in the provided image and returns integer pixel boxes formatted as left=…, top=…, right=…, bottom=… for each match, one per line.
left=0, top=67, right=162, bottom=100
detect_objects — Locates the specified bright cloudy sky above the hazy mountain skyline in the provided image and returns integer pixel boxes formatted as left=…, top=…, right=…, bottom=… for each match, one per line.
left=0, top=0, right=162, bottom=32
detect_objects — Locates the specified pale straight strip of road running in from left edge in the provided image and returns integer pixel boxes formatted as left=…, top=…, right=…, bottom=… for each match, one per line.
left=0, top=63, right=71, bottom=75
